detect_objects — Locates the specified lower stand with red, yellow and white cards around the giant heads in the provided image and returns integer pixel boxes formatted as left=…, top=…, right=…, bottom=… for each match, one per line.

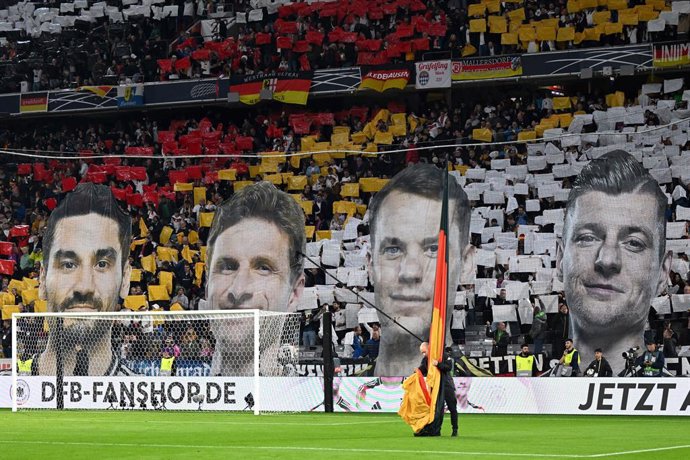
left=0, top=71, right=690, bottom=374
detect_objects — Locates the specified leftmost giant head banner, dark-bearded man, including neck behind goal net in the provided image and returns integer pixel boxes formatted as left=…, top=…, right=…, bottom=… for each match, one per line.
left=24, top=183, right=131, bottom=375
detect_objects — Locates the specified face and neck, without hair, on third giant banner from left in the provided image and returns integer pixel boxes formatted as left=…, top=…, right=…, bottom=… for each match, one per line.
left=370, top=191, right=471, bottom=375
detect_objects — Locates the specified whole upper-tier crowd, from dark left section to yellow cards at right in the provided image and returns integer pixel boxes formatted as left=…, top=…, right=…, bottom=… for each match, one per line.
left=0, top=0, right=689, bottom=92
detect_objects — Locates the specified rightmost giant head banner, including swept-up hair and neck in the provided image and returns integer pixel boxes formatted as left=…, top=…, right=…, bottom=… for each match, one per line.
left=557, top=150, right=672, bottom=370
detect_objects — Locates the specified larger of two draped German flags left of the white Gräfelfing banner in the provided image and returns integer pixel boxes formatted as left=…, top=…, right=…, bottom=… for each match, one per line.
left=230, top=72, right=311, bottom=105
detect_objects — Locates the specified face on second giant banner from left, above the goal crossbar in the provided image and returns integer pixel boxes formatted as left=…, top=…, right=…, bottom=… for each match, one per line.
left=208, top=218, right=304, bottom=311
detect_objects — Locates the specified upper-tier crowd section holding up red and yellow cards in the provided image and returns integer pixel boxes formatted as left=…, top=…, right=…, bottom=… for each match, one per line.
left=159, top=0, right=688, bottom=78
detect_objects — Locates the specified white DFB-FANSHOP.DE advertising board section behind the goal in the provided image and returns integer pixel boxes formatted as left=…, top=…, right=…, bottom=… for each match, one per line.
left=6, top=376, right=323, bottom=411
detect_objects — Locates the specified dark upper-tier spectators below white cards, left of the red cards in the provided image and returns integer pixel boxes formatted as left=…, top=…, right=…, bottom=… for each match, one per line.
left=0, top=0, right=206, bottom=93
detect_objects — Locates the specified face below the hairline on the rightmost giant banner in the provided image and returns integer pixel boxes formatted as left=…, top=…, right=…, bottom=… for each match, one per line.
left=559, top=191, right=670, bottom=335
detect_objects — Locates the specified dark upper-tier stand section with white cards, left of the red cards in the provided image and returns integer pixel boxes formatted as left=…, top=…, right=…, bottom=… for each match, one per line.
left=0, top=0, right=206, bottom=92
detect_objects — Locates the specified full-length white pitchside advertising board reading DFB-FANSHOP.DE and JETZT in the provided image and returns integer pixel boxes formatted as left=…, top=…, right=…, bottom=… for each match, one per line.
left=0, top=376, right=690, bottom=415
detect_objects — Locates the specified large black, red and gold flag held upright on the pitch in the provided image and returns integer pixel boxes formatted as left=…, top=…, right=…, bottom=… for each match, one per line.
left=398, top=171, right=448, bottom=435
